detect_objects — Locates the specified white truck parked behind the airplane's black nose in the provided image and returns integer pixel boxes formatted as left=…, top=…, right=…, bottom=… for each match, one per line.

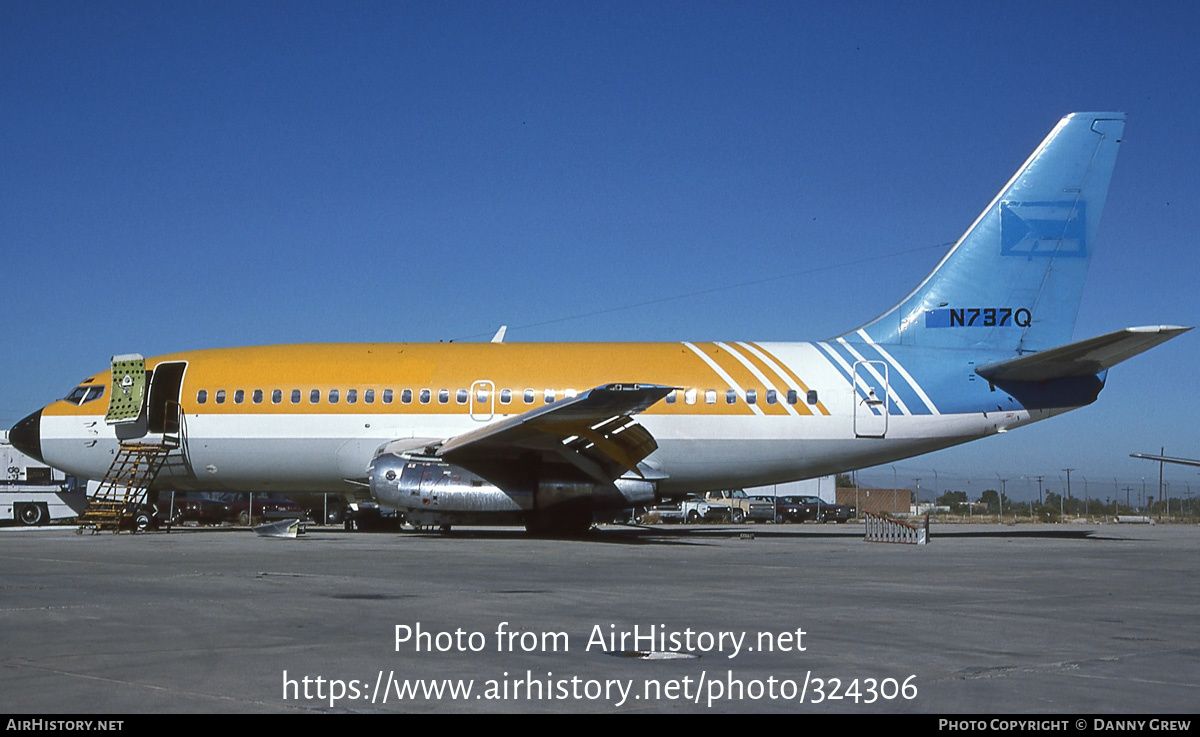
left=0, top=430, right=88, bottom=526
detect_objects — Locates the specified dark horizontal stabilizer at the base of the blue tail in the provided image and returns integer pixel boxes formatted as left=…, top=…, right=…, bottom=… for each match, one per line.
left=976, top=325, right=1192, bottom=382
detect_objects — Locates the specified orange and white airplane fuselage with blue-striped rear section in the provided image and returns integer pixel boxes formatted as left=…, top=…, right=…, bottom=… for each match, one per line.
left=32, top=341, right=1080, bottom=496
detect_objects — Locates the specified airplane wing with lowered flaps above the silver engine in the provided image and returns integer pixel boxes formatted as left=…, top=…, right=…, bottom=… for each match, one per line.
left=437, top=384, right=674, bottom=489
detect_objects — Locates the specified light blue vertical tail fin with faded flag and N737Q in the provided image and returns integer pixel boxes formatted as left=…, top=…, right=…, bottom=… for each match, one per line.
left=845, top=113, right=1124, bottom=353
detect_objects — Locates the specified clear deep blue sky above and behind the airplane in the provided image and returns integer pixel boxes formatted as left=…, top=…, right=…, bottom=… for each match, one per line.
left=0, top=0, right=1200, bottom=497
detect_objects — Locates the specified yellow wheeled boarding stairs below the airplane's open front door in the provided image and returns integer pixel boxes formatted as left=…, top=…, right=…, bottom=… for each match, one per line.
left=77, top=435, right=179, bottom=534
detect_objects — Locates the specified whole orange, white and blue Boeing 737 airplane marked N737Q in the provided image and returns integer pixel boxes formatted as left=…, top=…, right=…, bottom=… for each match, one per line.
left=10, top=113, right=1189, bottom=532
